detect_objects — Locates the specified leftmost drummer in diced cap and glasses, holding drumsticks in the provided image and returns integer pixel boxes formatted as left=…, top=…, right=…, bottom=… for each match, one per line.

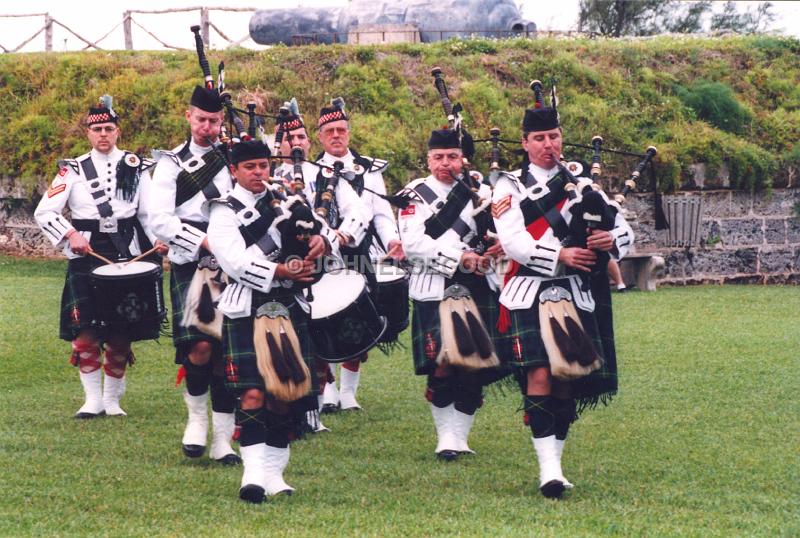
left=34, top=96, right=167, bottom=419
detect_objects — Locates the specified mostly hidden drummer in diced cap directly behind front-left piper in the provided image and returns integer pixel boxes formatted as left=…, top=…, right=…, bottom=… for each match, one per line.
left=275, top=100, right=371, bottom=430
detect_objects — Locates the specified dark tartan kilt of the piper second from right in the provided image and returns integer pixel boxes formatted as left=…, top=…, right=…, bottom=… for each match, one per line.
left=411, top=278, right=510, bottom=385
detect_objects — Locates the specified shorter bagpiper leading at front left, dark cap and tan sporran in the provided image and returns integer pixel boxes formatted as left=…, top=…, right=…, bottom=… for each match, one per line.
left=208, top=137, right=337, bottom=503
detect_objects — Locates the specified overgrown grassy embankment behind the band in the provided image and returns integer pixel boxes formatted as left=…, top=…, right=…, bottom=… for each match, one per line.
left=0, top=34, right=800, bottom=195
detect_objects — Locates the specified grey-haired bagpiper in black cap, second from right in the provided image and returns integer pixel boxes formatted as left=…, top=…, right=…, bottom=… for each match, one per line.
left=399, top=129, right=503, bottom=461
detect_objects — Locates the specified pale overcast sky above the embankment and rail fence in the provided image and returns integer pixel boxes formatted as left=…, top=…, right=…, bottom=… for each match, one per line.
left=0, top=0, right=800, bottom=52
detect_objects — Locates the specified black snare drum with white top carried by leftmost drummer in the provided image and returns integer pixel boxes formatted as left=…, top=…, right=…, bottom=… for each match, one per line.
left=91, top=262, right=167, bottom=341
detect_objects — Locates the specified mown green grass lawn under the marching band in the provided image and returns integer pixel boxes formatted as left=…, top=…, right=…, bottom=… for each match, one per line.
left=0, top=257, right=800, bottom=537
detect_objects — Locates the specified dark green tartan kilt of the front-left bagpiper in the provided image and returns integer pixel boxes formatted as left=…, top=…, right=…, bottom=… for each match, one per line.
left=222, top=291, right=319, bottom=402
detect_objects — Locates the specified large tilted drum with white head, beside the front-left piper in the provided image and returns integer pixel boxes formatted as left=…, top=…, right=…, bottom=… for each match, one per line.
left=309, top=269, right=386, bottom=362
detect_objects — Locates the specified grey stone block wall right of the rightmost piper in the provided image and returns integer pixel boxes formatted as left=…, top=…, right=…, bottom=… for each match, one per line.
left=625, top=189, right=800, bottom=285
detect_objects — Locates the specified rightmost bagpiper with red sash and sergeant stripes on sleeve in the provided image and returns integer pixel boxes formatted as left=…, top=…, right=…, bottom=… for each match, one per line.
left=492, top=91, right=633, bottom=498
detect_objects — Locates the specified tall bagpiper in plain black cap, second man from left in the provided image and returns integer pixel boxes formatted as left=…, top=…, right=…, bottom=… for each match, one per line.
left=147, top=86, right=241, bottom=465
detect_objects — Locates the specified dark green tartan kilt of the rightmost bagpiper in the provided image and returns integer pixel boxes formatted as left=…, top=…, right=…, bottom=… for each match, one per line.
left=498, top=277, right=617, bottom=408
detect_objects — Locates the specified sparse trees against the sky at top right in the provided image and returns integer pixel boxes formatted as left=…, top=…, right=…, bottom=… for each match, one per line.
left=578, top=0, right=775, bottom=37
